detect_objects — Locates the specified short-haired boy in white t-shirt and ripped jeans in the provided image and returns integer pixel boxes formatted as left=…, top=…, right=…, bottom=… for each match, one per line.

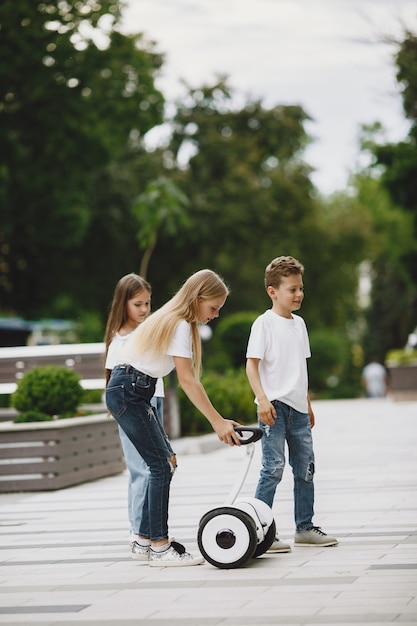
left=246, top=256, right=338, bottom=552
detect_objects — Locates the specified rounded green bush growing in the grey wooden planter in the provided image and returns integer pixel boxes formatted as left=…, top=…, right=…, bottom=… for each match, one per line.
left=11, top=365, right=83, bottom=419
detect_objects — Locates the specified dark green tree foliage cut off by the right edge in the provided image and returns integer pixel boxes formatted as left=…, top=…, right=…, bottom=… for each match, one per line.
left=352, top=31, right=417, bottom=356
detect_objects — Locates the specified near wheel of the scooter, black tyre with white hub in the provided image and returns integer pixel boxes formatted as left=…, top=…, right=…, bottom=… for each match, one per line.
left=197, top=506, right=257, bottom=569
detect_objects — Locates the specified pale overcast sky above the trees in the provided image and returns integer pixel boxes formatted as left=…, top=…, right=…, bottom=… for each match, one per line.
left=119, top=0, right=417, bottom=193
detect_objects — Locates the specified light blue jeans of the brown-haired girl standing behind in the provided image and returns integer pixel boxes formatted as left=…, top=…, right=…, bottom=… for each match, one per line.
left=119, top=396, right=164, bottom=535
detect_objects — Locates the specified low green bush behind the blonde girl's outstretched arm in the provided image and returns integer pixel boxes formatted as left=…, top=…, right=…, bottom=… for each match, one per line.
left=178, top=368, right=256, bottom=436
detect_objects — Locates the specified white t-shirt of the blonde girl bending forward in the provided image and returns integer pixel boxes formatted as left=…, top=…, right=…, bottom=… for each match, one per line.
left=120, top=320, right=192, bottom=378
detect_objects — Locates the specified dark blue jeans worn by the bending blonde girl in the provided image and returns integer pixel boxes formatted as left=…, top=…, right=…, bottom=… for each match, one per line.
left=106, top=365, right=175, bottom=541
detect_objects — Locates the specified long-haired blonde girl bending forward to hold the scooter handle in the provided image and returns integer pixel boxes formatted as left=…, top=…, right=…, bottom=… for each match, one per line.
left=106, top=270, right=240, bottom=567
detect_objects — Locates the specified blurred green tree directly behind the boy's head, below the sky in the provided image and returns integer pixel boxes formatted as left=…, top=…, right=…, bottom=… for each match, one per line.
left=145, top=79, right=362, bottom=336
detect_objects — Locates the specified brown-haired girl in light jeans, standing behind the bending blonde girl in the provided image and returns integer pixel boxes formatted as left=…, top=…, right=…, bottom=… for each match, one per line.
left=104, top=274, right=164, bottom=561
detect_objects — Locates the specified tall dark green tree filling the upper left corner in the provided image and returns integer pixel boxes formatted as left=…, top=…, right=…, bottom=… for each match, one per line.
left=0, top=0, right=163, bottom=316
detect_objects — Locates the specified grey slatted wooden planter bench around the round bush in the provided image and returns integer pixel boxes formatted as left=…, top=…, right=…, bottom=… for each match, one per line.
left=0, top=343, right=125, bottom=493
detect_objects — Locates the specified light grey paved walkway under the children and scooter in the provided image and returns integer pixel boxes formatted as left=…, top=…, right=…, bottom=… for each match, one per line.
left=0, top=399, right=417, bottom=626
